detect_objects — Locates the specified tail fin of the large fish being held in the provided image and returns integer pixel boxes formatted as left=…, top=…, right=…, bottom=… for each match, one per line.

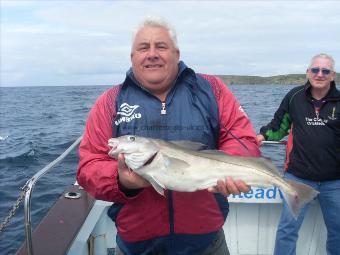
left=282, top=179, right=319, bottom=219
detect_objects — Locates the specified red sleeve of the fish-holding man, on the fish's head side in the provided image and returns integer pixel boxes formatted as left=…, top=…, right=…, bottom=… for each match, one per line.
left=77, top=87, right=128, bottom=203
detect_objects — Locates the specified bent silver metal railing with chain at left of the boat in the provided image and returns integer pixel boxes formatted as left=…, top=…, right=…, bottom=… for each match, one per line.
left=24, top=136, right=82, bottom=255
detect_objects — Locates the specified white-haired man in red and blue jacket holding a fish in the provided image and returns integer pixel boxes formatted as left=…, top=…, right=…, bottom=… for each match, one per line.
left=77, top=18, right=260, bottom=255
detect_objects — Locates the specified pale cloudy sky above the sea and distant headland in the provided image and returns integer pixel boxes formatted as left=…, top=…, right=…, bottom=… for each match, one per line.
left=0, top=0, right=340, bottom=87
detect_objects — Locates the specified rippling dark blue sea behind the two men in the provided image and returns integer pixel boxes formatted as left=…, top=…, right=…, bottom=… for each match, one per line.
left=0, top=85, right=293, bottom=255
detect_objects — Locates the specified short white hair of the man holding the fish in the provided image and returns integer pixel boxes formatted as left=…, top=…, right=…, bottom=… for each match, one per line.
left=132, top=16, right=178, bottom=49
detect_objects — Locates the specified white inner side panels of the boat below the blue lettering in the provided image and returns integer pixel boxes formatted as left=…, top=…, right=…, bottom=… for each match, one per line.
left=68, top=188, right=327, bottom=255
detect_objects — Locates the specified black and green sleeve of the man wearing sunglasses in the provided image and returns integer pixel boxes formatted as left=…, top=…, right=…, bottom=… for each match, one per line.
left=260, top=93, right=292, bottom=141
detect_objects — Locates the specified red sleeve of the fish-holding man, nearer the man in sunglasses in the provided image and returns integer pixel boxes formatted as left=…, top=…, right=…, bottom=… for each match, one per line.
left=213, top=77, right=261, bottom=157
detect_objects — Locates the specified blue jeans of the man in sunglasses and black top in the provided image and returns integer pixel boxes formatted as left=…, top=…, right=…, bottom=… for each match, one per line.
left=274, top=173, right=340, bottom=255
